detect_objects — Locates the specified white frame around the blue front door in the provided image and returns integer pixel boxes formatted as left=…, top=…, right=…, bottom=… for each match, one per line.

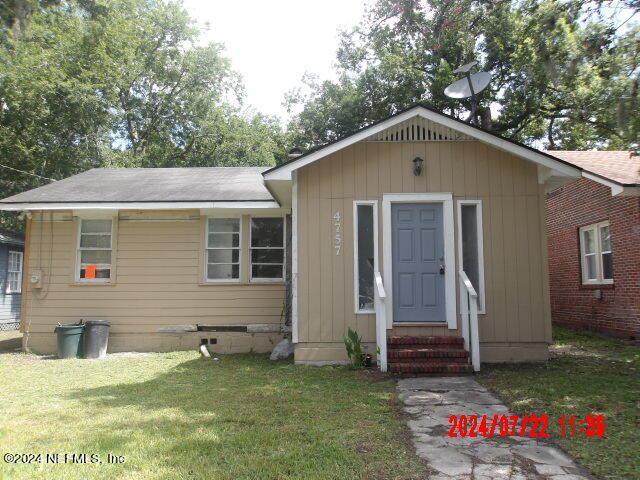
left=382, top=193, right=457, bottom=330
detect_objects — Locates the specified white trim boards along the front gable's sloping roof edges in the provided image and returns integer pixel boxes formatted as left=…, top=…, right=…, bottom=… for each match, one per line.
left=264, top=106, right=581, bottom=181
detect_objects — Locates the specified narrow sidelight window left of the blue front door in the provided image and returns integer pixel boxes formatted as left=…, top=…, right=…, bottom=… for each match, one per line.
left=356, top=205, right=375, bottom=311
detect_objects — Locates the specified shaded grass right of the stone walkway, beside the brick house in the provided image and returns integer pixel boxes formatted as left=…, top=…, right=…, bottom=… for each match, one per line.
left=478, top=328, right=640, bottom=480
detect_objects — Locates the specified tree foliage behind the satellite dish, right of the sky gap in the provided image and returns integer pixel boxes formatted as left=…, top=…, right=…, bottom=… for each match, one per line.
left=287, top=0, right=640, bottom=149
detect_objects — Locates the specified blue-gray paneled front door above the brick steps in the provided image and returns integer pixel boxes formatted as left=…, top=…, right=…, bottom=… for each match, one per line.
left=391, top=203, right=446, bottom=323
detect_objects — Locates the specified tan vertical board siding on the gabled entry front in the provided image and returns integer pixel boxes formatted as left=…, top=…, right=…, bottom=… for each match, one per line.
left=298, top=141, right=549, bottom=348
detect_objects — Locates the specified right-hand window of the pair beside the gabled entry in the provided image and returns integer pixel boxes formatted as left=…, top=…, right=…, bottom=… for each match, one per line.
left=250, top=217, right=285, bottom=282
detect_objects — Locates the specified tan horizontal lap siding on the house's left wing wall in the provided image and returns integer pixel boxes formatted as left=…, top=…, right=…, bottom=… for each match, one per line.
left=27, top=212, right=285, bottom=344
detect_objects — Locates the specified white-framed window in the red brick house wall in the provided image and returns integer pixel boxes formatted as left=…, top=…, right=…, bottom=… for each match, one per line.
left=580, top=222, right=613, bottom=284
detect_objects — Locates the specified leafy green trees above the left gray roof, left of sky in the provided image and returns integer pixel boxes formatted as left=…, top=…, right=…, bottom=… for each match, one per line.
left=0, top=0, right=285, bottom=231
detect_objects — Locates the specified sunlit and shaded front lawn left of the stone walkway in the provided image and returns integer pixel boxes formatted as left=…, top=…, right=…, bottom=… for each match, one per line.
left=0, top=333, right=426, bottom=480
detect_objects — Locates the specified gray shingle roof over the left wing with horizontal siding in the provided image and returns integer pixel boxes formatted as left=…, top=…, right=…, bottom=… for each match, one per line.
left=0, top=167, right=273, bottom=203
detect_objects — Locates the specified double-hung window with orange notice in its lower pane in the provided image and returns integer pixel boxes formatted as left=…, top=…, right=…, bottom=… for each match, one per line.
left=77, top=219, right=113, bottom=283
